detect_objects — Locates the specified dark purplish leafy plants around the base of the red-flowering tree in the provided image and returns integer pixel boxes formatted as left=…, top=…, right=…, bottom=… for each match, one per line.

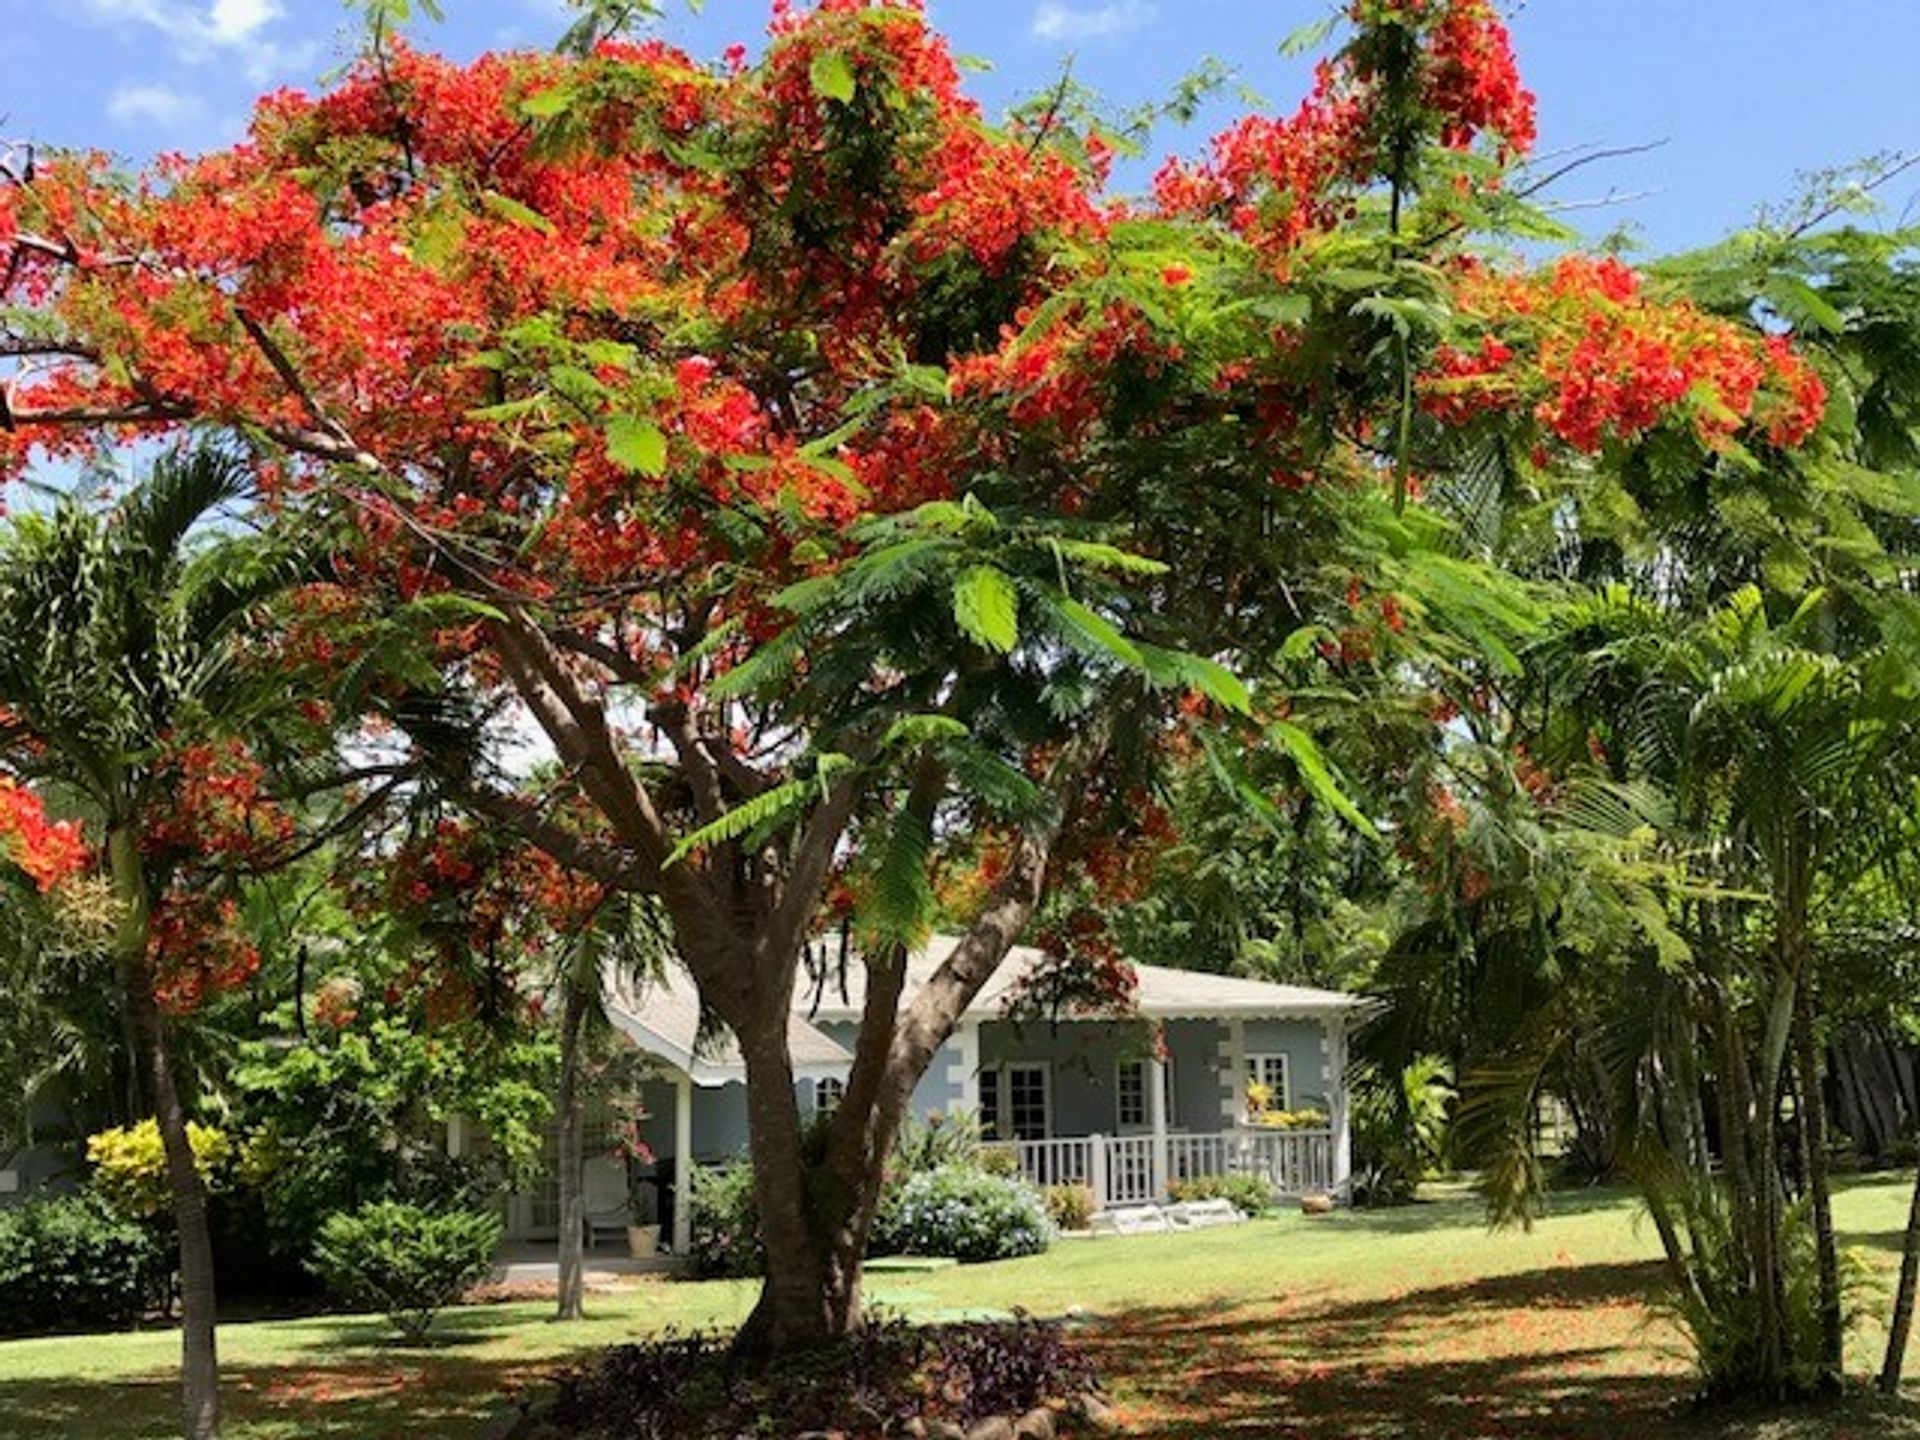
left=547, top=1317, right=1098, bottom=1440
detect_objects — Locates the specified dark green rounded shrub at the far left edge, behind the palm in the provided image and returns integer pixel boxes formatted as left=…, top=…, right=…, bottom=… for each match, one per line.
left=0, top=1192, right=167, bottom=1334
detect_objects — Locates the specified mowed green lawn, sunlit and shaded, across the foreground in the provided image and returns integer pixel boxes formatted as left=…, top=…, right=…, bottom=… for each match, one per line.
left=11, top=1177, right=1920, bottom=1440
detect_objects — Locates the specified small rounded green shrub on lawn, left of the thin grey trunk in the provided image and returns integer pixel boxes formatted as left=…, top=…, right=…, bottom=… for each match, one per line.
left=313, top=1200, right=501, bottom=1342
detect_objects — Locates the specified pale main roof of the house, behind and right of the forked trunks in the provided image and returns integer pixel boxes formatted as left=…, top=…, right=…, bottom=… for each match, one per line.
left=797, top=935, right=1373, bottom=1021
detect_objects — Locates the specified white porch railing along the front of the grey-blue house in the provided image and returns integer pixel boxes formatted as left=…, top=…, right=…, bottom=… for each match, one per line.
left=996, top=1127, right=1346, bottom=1210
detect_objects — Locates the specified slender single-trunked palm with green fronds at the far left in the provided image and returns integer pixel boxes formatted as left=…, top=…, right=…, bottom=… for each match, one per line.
left=0, top=451, right=309, bottom=1440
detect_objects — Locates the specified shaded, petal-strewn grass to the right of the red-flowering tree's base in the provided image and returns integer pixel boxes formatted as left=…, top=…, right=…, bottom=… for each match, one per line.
left=1085, top=1263, right=1920, bottom=1440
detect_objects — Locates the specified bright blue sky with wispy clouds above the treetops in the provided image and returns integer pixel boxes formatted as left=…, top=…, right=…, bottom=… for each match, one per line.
left=0, top=0, right=1920, bottom=248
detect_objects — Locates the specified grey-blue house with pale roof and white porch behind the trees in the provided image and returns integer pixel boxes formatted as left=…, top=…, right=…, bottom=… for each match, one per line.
left=507, top=937, right=1371, bottom=1252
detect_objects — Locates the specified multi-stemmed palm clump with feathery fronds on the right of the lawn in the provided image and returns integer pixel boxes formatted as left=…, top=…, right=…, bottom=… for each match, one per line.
left=1469, top=588, right=1916, bottom=1396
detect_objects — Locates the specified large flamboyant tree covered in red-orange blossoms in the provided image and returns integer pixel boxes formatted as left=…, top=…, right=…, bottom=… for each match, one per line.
left=0, top=0, right=1818, bottom=1374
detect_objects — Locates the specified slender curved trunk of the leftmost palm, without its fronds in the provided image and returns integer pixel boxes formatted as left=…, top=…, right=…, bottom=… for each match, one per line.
left=108, top=826, right=221, bottom=1440
